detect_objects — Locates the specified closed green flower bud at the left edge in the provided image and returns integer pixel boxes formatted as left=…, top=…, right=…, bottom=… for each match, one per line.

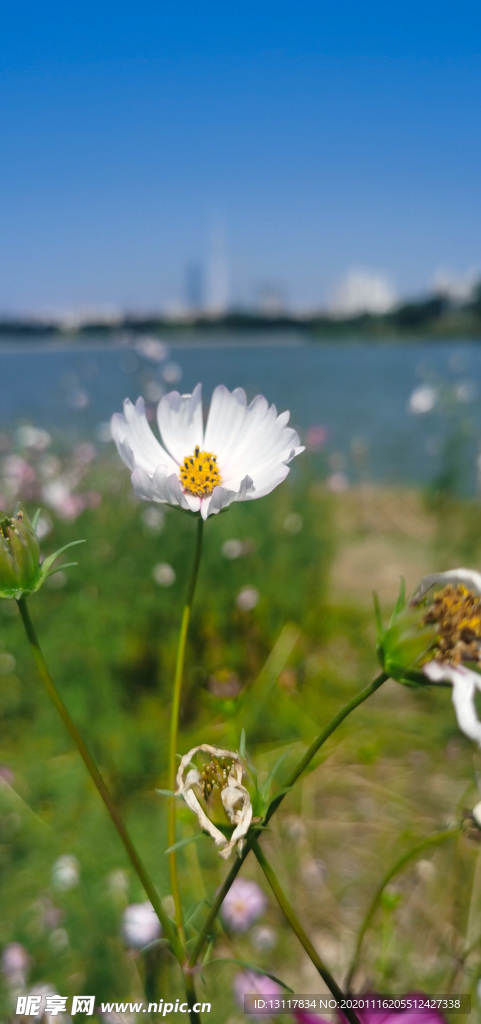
left=0, top=505, right=82, bottom=601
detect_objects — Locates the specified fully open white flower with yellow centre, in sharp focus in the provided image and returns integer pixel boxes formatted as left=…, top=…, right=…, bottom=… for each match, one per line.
left=112, top=384, right=304, bottom=519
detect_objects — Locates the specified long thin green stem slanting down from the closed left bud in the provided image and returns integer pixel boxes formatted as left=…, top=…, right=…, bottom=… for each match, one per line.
left=16, top=597, right=183, bottom=964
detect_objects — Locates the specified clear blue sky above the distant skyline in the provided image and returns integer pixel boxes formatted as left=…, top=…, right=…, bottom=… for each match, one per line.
left=0, top=0, right=481, bottom=311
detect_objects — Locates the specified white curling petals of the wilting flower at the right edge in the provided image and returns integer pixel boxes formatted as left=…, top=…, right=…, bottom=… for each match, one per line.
left=410, top=568, right=481, bottom=746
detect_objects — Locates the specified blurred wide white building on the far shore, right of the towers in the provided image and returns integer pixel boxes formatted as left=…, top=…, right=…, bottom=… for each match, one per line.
left=329, top=268, right=396, bottom=316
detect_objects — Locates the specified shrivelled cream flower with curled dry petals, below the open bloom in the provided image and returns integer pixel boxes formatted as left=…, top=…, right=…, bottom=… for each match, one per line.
left=177, top=743, right=252, bottom=857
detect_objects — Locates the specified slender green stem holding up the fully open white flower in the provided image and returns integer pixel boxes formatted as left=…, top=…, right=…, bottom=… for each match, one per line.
left=168, top=516, right=204, bottom=938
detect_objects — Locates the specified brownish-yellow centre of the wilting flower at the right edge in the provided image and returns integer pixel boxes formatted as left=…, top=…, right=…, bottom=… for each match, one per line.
left=423, top=584, right=481, bottom=665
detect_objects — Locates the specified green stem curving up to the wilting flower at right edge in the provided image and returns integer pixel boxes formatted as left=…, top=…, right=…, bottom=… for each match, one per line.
left=188, top=672, right=389, bottom=967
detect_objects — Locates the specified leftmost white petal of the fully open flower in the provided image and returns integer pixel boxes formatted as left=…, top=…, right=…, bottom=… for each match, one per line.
left=111, top=398, right=176, bottom=473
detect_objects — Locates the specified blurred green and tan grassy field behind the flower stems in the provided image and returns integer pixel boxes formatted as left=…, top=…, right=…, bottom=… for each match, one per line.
left=0, top=462, right=481, bottom=1024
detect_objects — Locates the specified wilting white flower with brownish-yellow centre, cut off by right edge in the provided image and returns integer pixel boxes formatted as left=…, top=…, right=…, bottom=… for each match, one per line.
left=411, top=568, right=481, bottom=746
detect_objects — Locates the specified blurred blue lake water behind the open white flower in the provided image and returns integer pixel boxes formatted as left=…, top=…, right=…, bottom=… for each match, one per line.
left=0, top=333, right=481, bottom=492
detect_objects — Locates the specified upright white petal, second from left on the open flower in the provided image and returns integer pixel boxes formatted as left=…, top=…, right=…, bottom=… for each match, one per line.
left=157, top=384, right=204, bottom=465
